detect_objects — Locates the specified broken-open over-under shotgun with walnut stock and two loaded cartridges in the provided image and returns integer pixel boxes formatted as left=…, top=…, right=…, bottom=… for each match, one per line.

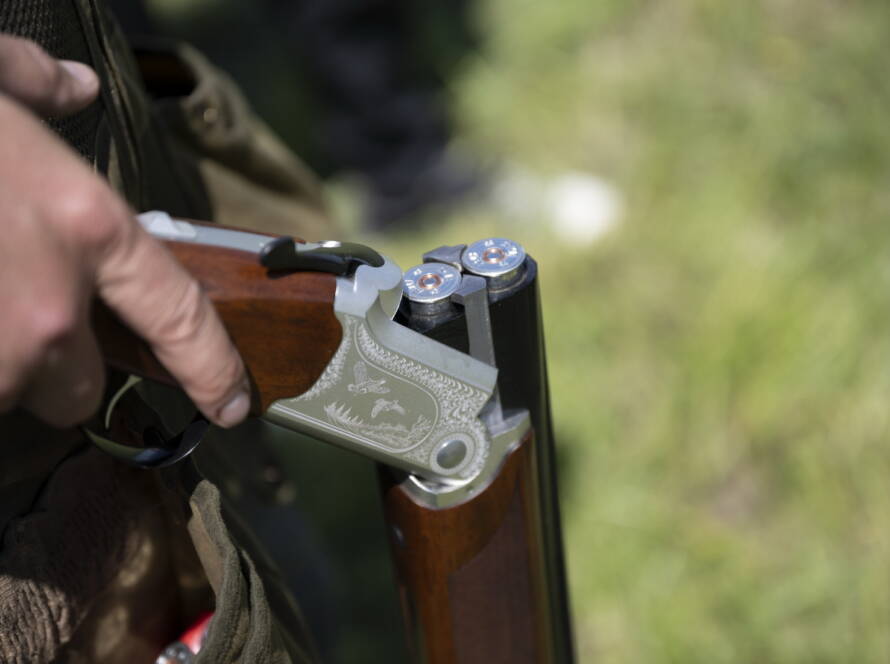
left=87, top=212, right=574, bottom=664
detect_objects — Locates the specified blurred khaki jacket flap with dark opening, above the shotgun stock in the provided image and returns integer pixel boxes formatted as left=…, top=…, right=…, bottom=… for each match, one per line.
left=136, top=40, right=338, bottom=241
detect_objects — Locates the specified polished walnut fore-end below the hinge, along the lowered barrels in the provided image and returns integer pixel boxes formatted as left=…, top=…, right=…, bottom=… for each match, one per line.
left=384, top=432, right=552, bottom=664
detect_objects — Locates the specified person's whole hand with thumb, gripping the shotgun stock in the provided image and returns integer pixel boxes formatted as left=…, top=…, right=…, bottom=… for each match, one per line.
left=0, top=35, right=250, bottom=427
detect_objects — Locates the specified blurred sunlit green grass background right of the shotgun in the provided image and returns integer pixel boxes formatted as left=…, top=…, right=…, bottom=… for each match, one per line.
left=153, top=0, right=890, bottom=663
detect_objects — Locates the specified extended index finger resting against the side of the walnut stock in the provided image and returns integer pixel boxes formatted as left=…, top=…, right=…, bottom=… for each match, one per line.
left=96, top=208, right=250, bottom=427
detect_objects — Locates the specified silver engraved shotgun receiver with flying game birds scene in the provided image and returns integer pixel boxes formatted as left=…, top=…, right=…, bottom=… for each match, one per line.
left=266, top=249, right=497, bottom=484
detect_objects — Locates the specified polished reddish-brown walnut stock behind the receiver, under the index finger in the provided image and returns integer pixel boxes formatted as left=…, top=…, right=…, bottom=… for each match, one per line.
left=93, top=242, right=342, bottom=415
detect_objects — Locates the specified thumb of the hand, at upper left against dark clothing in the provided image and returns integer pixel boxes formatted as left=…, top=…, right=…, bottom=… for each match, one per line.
left=0, top=35, right=99, bottom=116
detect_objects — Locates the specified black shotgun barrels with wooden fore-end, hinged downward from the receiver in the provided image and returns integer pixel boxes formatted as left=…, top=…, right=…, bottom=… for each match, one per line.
left=384, top=246, right=575, bottom=664
